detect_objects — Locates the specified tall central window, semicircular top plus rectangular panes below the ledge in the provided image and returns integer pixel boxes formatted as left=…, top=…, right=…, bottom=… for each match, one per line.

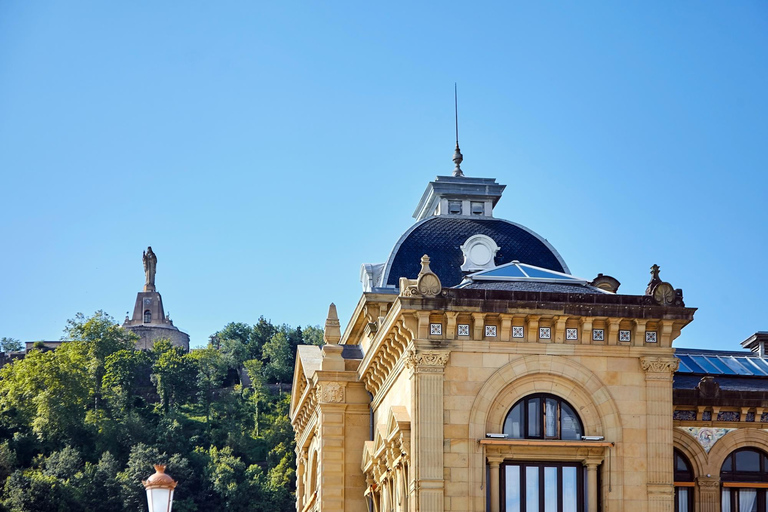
left=501, top=393, right=587, bottom=512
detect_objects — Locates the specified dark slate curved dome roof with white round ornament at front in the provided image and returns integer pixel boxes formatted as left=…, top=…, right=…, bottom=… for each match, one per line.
left=382, top=215, right=570, bottom=287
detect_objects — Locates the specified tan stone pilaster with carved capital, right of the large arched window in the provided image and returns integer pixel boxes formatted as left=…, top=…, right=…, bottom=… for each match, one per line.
left=640, top=357, right=680, bottom=512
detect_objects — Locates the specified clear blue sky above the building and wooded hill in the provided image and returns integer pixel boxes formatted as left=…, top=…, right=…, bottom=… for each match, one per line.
left=0, top=0, right=768, bottom=349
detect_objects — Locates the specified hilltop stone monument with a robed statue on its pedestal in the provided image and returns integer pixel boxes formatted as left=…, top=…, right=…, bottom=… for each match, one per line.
left=123, top=247, right=189, bottom=351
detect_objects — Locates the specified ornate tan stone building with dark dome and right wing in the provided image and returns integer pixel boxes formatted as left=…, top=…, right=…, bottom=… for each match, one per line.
left=290, top=147, right=768, bottom=512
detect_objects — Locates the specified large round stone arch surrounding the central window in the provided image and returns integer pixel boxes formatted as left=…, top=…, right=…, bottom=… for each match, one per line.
left=467, top=355, right=622, bottom=512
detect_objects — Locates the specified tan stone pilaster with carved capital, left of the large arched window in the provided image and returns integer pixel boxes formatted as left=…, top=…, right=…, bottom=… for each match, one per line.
left=406, top=350, right=450, bottom=512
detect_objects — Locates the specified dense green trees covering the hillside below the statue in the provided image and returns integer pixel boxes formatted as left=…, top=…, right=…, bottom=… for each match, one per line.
left=0, top=311, right=322, bottom=512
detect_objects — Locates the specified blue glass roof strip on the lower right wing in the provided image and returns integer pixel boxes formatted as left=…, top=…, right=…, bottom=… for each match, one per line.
left=675, top=349, right=768, bottom=377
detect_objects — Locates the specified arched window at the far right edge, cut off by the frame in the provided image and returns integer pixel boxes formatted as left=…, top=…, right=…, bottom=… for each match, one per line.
left=720, top=448, right=768, bottom=512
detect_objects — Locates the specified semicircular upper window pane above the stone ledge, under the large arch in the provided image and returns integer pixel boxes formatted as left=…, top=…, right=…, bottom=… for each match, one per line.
left=504, top=393, right=584, bottom=440
